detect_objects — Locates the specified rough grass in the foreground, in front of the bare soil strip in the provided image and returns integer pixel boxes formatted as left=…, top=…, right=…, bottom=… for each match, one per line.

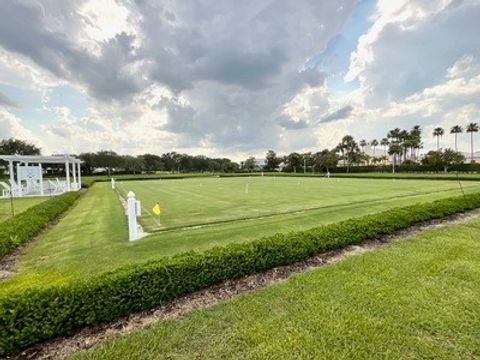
left=72, top=218, right=480, bottom=359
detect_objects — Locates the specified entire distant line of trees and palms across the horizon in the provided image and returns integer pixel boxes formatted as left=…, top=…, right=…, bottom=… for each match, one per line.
left=0, top=123, right=480, bottom=174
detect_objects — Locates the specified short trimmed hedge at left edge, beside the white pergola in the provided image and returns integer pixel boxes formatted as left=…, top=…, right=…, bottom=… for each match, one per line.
left=0, top=192, right=80, bottom=257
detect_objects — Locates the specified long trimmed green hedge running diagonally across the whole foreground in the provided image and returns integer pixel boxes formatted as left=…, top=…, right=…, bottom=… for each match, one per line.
left=0, top=194, right=480, bottom=354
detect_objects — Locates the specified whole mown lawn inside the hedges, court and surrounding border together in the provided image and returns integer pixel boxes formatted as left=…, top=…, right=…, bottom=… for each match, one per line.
left=0, top=178, right=480, bottom=294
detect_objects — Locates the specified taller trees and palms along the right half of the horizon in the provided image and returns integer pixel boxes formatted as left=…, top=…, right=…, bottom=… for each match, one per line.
left=248, top=123, right=479, bottom=172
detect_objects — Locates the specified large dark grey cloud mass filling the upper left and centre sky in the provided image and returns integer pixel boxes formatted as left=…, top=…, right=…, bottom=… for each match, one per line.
left=0, top=0, right=355, bottom=156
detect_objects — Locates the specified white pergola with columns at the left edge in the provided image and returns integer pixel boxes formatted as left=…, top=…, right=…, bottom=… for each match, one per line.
left=0, top=155, right=82, bottom=197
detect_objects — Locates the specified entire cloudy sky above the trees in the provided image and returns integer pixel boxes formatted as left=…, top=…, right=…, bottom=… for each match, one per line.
left=0, top=0, right=480, bottom=160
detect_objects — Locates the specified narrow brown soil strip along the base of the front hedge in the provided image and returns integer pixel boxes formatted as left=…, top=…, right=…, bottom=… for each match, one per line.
left=6, top=209, right=480, bottom=359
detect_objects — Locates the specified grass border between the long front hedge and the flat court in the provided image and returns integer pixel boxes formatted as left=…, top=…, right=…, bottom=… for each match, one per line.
left=0, top=179, right=480, bottom=294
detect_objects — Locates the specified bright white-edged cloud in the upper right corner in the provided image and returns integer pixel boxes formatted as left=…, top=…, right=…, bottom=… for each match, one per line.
left=345, top=0, right=480, bottom=106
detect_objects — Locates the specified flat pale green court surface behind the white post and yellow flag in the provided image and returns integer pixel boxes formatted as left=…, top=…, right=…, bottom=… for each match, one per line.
left=117, top=176, right=477, bottom=231
